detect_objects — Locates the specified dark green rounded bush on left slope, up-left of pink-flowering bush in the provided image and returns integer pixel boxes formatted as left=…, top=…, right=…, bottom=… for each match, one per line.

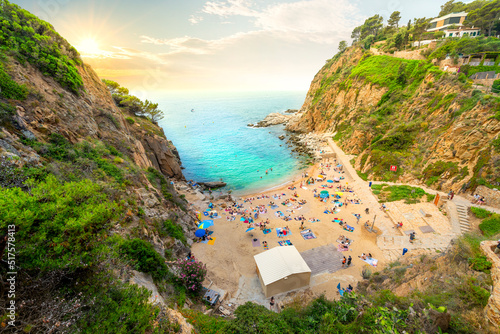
left=120, top=239, right=167, bottom=280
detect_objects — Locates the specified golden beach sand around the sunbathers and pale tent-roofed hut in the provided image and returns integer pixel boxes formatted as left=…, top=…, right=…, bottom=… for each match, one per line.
left=192, top=141, right=385, bottom=306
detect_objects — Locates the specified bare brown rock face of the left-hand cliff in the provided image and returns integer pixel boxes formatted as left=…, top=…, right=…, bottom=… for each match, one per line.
left=5, top=59, right=183, bottom=179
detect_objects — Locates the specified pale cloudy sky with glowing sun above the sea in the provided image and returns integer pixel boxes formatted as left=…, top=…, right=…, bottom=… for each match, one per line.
left=12, top=0, right=445, bottom=91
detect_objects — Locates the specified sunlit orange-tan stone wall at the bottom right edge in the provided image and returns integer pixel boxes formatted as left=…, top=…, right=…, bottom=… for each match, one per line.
left=481, top=241, right=500, bottom=328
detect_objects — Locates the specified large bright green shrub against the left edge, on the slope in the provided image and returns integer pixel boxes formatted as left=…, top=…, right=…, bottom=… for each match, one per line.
left=0, top=175, right=122, bottom=271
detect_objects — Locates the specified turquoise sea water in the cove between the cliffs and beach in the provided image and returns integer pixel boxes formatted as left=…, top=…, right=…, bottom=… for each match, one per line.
left=155, top=92, right=306, bottom=194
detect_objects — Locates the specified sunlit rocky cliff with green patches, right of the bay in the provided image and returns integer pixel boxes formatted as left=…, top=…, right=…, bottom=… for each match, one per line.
left=287, top=47, right=500, bottom=191
